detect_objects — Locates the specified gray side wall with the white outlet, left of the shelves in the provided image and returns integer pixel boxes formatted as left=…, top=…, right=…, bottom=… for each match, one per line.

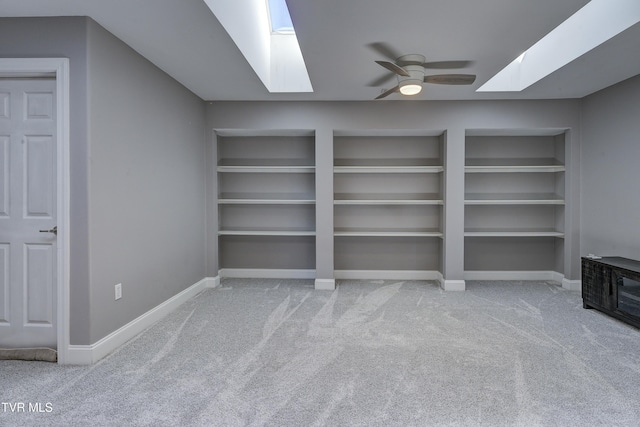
left=88, top=21, right=205, bottom=342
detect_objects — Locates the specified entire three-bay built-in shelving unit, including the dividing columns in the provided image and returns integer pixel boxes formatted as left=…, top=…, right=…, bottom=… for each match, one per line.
left=209, top=125, right=575, bottom=289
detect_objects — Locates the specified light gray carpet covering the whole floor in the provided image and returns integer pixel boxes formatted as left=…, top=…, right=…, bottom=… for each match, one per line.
left=0, top=279, right=640, bottom=426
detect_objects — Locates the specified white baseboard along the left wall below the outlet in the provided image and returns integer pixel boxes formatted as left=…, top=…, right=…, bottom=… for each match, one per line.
left=65, top=278, right=209, bottom=365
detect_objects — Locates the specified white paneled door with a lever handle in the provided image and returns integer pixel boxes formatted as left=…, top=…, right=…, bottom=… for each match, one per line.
left=0, top=79, right=57, bottom=348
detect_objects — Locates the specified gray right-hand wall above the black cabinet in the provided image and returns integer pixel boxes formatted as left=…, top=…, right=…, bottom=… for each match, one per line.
left=581, top=76, right=640, bottom=259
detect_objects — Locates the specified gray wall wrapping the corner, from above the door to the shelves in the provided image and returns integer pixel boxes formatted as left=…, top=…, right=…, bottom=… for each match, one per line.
left=0, top=17, right=205, bottom=345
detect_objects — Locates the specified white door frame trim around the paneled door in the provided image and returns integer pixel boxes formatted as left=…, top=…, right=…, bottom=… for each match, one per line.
left=0, top=58, right=71, bottom=364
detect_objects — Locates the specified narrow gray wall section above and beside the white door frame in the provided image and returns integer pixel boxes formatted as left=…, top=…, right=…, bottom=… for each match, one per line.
left=0, top=17, right=92, bottom=344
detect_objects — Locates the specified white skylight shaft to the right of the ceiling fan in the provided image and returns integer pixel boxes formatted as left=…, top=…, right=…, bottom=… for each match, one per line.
left=477, top=0, right=640, bottom=92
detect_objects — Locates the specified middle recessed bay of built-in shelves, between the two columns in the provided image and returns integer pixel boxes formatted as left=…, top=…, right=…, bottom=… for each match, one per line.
left=333, top=131, right=444, bottom=278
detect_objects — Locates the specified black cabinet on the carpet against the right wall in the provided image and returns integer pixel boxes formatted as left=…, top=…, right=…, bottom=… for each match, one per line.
left=582, top=257, right=640, bottom=327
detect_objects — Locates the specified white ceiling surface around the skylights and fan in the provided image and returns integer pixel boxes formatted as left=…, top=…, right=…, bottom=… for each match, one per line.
left=0, top=0, right=640, bottom=102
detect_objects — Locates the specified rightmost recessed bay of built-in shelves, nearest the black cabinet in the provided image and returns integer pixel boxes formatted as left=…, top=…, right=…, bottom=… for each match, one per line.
left=464, top=130, right=565, bottom=275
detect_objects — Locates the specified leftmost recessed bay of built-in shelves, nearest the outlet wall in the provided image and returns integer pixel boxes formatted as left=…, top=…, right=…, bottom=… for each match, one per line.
left=216, top=130, right=316, bottom=277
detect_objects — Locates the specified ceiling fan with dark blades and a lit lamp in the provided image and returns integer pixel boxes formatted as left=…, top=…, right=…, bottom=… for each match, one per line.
left=369, top=43, right=476, bottom=99
